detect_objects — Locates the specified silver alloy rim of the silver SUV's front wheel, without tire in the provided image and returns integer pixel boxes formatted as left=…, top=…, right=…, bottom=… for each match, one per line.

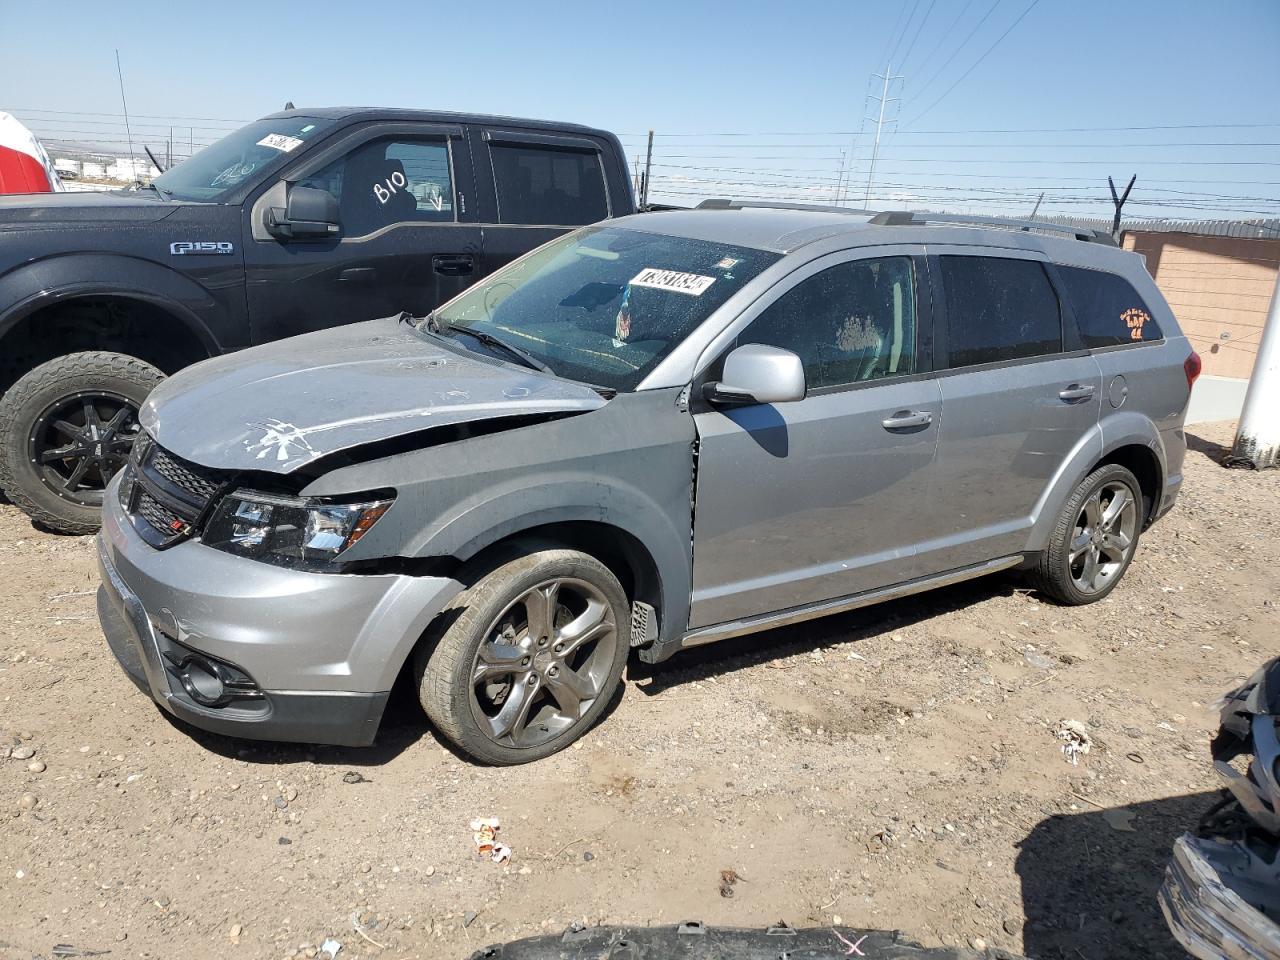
left=470, top=577, right=618, bottom=748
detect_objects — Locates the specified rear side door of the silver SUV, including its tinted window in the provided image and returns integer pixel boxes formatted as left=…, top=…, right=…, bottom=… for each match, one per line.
left=919, top=247, right=1102, bottom=576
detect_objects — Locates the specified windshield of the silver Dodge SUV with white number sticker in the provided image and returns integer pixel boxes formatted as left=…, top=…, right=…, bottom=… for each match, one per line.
left=434, top=227, right=778, bottom=390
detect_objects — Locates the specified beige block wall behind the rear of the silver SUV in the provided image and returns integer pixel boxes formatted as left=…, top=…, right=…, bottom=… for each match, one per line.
left=1124, top=230, right=1280, bottom=378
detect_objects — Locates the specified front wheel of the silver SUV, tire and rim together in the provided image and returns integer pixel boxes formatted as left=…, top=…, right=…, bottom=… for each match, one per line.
left=415, top=548, right=630, bottom=765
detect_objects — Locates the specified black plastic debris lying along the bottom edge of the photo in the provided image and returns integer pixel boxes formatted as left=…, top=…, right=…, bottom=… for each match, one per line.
left=471, top=923, right=1023, bottom=960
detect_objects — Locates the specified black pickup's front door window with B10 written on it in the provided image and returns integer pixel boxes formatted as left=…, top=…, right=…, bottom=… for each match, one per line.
left=298, top=140, right=453, bottom=237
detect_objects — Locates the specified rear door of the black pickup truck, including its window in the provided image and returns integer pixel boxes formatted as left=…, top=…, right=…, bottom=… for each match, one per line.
left=470, top=127, right=616, bottom=274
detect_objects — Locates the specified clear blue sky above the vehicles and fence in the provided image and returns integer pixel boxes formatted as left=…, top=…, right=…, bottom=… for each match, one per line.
left=0, top=0, right=1280, bottom=218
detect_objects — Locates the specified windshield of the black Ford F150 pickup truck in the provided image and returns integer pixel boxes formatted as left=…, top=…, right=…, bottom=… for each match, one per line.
left=154, top=116, right=333, bottom=201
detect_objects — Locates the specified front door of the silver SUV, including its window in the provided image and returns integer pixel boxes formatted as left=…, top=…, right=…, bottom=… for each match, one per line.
left=690, top=248, right=942, bottom=627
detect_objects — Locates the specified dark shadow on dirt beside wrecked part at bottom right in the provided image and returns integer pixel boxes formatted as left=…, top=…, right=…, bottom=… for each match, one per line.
left=1015, top=791, right=1221, bottom=960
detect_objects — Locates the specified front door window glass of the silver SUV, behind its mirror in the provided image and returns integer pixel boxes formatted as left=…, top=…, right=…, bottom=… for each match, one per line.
left=739, top=257, right=915, bottom=389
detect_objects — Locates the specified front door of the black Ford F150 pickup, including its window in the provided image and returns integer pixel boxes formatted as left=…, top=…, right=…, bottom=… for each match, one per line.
left=244, top=124, right=481, bottom=343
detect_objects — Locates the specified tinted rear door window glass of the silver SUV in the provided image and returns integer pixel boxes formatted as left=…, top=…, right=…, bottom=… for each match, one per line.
left=941, top=256, right=1062, bottom=367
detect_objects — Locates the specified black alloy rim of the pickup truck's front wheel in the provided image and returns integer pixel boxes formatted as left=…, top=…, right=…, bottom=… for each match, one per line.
left=27, top=392, right=141, bottom=506
